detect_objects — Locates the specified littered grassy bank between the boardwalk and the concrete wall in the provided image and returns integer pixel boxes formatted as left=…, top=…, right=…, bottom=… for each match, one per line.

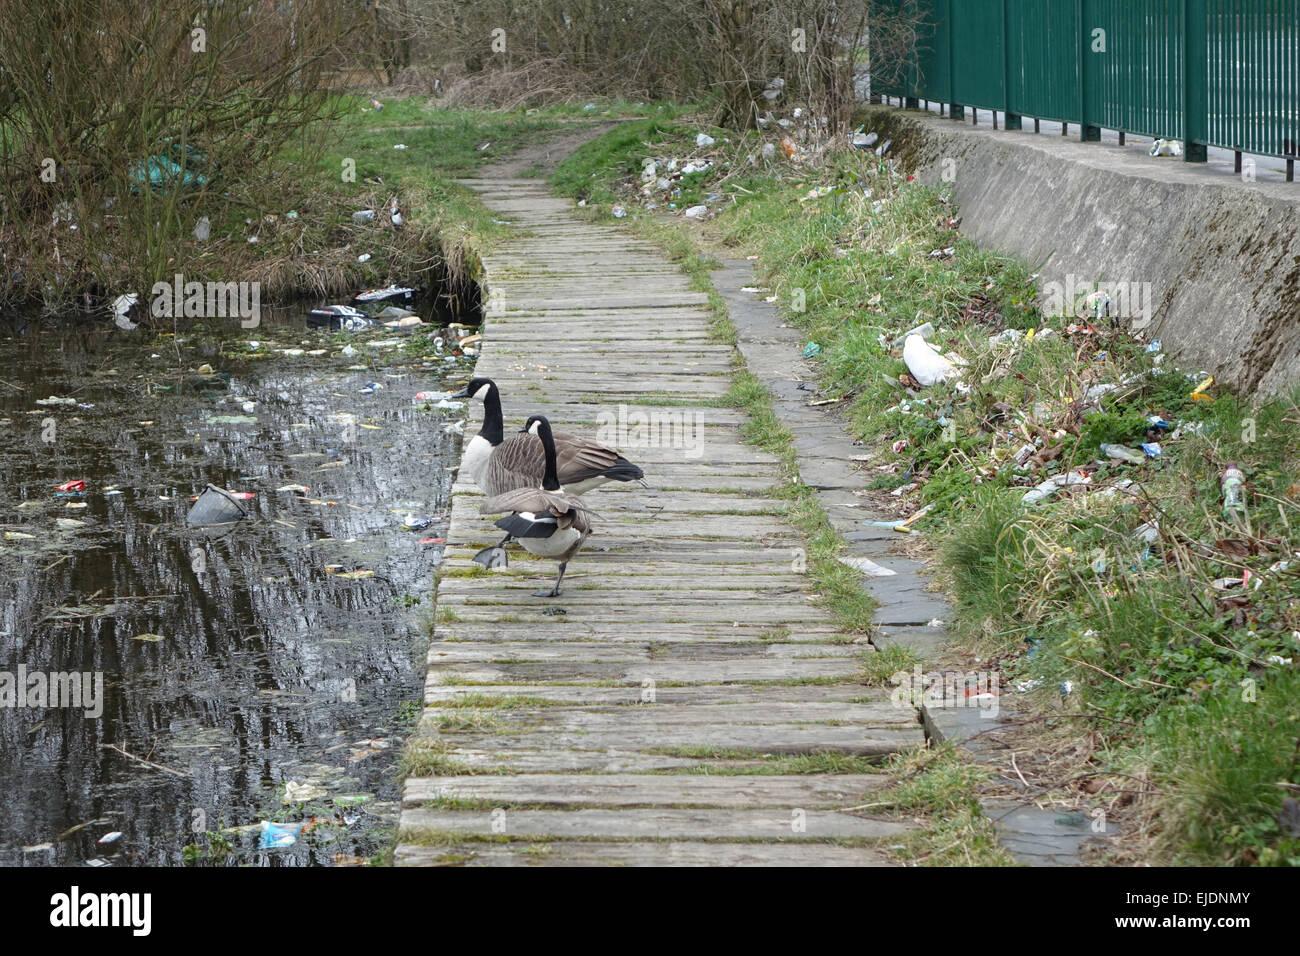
left=553, top=113, right=1300, bottom=865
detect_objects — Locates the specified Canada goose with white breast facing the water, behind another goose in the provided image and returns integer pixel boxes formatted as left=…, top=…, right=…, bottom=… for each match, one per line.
left=452, top=378, right=645, bottom=496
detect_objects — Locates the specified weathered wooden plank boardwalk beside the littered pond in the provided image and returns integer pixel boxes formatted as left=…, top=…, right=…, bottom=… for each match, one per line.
left=395, top=179, right=923, bottom=865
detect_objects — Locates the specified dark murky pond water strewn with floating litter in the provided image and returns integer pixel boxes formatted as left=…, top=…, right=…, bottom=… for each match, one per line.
left=0, top=308, right=471, bottom=866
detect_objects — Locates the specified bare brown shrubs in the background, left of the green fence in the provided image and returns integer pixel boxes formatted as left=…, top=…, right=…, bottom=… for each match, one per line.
left=408, top=0, right=918, bottom=129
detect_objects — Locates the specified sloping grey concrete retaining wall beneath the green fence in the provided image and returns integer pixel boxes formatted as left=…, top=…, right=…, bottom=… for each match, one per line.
left=867, top=107, right=1300, bottom=394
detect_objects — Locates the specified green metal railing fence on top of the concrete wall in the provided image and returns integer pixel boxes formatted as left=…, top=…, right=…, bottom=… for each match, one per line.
left=872, top=0, right=1300, bottom=178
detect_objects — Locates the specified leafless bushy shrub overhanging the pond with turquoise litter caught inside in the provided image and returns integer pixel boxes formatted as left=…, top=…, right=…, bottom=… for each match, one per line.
left=0, top=0, right=365, bottom=306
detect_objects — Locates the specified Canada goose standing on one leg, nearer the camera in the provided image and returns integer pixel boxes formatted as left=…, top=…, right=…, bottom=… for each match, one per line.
left=478, top=415, right=592, bottom=597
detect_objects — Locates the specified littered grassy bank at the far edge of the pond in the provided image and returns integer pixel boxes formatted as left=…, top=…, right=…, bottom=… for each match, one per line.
left=0, top=95, right=654, bottom=304
